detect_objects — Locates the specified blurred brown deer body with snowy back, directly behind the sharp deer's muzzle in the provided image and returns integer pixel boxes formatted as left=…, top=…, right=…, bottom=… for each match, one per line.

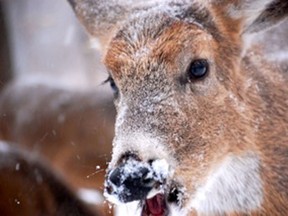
left=0, top=82, right=115, bottom=213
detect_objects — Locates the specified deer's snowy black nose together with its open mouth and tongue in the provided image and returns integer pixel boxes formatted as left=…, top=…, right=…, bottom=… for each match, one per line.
left=104, top=159, right=183, bottom=216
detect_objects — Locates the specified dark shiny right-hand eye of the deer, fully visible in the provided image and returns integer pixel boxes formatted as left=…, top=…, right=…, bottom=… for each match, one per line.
left=188, top=59, right=209, bottom=81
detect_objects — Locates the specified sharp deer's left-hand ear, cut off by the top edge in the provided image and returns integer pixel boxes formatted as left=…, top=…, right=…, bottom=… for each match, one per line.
left=68, top=0, right=131, bottom=49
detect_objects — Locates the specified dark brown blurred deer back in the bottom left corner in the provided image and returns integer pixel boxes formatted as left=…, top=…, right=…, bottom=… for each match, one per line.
left=0, top=140, right=102, bottom=216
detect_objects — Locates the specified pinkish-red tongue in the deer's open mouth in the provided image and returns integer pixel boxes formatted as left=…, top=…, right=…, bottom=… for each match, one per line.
left=142, top=194, right=166, bottom=216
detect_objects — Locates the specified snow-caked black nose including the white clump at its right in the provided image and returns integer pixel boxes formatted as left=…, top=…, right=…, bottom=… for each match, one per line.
left=104, top=157, right=169, bottom=205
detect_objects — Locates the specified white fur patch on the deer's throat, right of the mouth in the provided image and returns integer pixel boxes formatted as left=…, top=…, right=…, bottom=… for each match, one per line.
left=191, top=154, right=263, bottom=215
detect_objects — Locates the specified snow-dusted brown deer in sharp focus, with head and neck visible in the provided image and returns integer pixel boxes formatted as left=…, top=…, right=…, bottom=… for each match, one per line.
left=68, top=0, right=288, bottom=216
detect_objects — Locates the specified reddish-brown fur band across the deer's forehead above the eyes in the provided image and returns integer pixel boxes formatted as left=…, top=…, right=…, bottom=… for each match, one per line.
left=104, top=16, right=217, bottom=82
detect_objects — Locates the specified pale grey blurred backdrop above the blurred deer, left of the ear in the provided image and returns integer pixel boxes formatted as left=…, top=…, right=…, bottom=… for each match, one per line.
left=0, top=0, right=106, bottom=89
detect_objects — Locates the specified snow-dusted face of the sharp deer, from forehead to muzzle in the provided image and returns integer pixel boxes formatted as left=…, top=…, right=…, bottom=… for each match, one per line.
left=105, top=9, right=254, bottom=214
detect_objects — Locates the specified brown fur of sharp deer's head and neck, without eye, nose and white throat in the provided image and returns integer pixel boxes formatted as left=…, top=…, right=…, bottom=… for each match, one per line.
left=68, top=0, right=288, bottom=215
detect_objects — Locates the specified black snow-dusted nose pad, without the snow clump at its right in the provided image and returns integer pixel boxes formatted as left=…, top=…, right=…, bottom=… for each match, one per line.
left=106, top=160, right=155, bottom=202
